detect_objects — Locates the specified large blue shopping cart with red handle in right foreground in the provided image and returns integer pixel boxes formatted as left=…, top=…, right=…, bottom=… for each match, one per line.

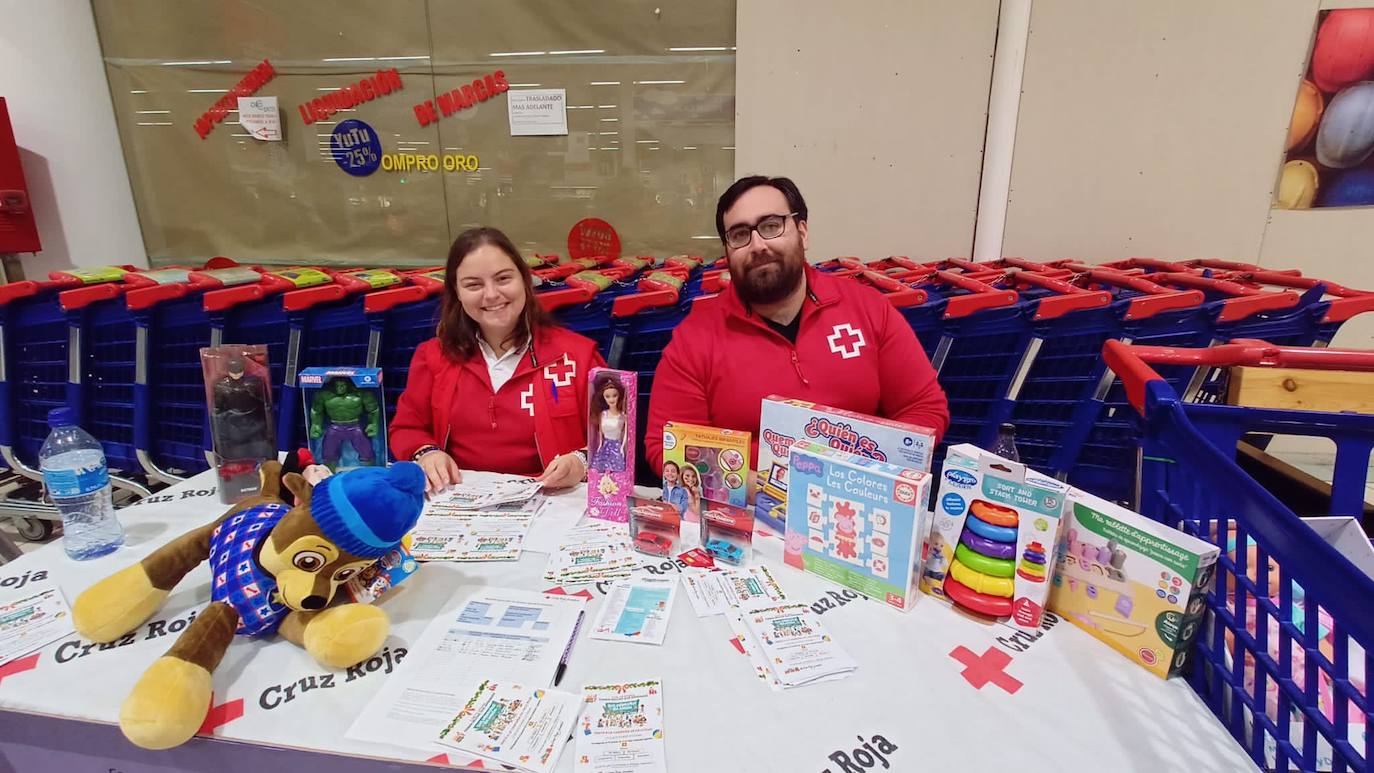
left=1103, top=341, right=1374, bottom=770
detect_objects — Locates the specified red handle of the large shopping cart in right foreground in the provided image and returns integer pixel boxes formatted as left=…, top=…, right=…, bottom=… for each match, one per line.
left=1102, top=338, right=1374, bottom=416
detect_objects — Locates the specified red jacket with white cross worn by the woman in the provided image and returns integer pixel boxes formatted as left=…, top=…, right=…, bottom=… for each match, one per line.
left=389, top=327, right=606, bottom=475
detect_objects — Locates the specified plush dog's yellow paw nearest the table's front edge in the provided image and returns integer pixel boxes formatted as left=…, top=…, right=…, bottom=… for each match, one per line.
left=120, top=655, right=212, bottom=750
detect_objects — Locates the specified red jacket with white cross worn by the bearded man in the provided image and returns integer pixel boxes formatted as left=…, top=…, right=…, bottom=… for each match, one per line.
left=644, top=266, right=949, bottom=472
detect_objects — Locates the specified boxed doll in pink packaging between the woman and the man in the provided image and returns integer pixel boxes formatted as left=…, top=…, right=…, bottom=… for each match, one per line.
left=587, top=368, right=639, bottom=523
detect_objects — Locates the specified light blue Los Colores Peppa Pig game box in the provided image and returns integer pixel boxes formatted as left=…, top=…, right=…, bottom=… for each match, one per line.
left=783, top=442, right=930, bottom=610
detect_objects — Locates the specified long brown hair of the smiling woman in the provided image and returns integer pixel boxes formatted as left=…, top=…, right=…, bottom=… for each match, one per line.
left=436, top=228, right=554, bottom=360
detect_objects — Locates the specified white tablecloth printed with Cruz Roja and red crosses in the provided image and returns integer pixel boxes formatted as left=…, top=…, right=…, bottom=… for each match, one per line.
left=0, top=472, right=1254, bottom=773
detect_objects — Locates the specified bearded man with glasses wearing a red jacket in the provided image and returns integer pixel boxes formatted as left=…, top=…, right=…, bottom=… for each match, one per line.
left=644, top=176, right=949, bottom=471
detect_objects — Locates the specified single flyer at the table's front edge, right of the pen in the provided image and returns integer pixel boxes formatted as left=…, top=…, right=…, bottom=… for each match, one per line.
left=576, top=680, right=668, bottom=773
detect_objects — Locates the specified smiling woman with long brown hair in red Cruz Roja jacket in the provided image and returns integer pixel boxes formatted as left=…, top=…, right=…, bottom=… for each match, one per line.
left=389, top=228, right=605, bottom=493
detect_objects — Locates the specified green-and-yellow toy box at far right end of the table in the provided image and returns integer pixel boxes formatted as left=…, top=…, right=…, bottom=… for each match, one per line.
left=1050, top=489, right=1220, bottom=678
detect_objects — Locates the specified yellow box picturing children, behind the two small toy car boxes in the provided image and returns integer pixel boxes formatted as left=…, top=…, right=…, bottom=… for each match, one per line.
left=664, top=422, right=749, bottom=508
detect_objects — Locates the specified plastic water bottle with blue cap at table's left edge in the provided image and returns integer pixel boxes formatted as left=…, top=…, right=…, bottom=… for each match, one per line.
left=38, top=408, right=124, bottom=562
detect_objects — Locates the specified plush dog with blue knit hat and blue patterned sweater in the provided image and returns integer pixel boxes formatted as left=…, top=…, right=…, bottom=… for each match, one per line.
left=73, top=461, right=425, bottom=750
